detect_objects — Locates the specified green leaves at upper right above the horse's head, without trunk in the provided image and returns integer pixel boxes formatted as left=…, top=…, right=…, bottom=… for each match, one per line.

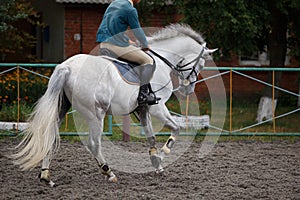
left=175, top=0, right=300, bottom=61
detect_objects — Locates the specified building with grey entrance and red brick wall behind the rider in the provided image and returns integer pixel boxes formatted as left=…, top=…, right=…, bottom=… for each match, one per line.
left=33, top=0, right=179, bottom=63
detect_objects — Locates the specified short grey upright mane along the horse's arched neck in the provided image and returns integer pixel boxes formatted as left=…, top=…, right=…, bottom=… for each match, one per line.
left=149, top=24, right=205, bottom=44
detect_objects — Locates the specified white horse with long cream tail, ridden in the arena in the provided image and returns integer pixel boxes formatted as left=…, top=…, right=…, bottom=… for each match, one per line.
left=13, top=24, right=216, bottom=186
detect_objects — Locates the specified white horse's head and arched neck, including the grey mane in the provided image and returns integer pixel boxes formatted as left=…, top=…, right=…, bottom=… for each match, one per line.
left=149, top=24, right=217, bottom=95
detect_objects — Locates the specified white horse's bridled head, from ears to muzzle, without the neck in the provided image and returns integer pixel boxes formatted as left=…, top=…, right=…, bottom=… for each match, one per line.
left=176, top=43, right=217, bottom=95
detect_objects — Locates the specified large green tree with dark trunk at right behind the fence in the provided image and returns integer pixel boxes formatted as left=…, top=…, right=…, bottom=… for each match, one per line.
left=176, top=0, right=300, bottom=122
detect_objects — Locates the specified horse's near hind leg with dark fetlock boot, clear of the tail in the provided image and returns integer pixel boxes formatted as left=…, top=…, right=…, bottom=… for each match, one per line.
left=88, top=108, right=118, bottom=183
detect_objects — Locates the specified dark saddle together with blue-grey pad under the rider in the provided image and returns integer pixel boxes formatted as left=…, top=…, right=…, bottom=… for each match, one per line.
left=100, top=48, right=140, bottom=85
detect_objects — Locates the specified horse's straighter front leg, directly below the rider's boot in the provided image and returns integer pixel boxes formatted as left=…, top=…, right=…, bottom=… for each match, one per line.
left=139, top=105, right=163, bottom=173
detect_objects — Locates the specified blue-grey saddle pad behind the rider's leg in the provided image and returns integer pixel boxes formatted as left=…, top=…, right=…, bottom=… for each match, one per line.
left=112, top=60, right=140, bottom=85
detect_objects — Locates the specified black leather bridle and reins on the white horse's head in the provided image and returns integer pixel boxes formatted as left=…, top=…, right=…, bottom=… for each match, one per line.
left=149, top=45, right=206, bottom=87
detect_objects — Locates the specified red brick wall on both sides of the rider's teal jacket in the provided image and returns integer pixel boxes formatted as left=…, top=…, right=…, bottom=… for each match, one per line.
left=64, top=4, right=180, bottom=58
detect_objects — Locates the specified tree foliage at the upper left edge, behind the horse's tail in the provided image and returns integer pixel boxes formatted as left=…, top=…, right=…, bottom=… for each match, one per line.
left=0, top=0, right=38, bottom=61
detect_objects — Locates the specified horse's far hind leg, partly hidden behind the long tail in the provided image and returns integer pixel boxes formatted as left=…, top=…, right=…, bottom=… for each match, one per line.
left=39, top=94, right=71, bottom=187
